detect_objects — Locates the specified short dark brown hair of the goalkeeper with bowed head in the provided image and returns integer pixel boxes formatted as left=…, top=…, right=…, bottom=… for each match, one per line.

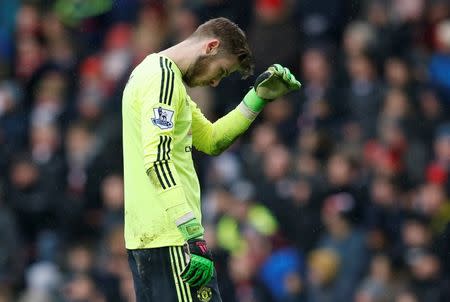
left=191, top=18, right=253, bottom=78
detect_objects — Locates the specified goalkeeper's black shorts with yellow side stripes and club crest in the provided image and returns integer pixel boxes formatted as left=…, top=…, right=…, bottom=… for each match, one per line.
left=128, top=246, right=222, bottom=302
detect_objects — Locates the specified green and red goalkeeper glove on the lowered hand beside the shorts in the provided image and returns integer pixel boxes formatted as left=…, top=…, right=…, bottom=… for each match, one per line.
left=178, top=218, right=214, bottom=287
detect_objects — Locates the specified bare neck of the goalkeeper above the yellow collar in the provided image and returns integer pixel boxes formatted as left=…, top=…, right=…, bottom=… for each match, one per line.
left=159, top=39, right=200, bottom=75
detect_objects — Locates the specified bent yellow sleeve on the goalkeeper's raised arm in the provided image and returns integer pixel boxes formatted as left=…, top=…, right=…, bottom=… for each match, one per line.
left=189, top=100, right=257, bottom=155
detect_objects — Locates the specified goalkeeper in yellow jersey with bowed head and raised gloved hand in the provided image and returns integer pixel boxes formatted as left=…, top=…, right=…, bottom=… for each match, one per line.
left=122, top=18, right=300, bottom=302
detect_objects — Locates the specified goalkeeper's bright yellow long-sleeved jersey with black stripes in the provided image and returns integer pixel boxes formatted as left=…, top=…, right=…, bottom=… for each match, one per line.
left=122, top=54, right=257, bottom=249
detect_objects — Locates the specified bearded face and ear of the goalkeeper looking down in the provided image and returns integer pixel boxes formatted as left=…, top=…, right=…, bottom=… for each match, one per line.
left=183, top=39, right=239, bottom=87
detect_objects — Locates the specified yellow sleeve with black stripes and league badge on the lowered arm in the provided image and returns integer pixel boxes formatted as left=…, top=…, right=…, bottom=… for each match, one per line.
left=138, top=58, right=191, bottom=222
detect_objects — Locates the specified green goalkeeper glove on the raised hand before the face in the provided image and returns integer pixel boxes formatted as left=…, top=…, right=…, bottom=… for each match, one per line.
left=244, top=64, right=301, bottom=112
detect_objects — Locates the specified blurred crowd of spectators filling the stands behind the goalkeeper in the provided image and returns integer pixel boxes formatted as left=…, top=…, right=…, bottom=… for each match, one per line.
left=0, top=0, right=450, bottom=302
